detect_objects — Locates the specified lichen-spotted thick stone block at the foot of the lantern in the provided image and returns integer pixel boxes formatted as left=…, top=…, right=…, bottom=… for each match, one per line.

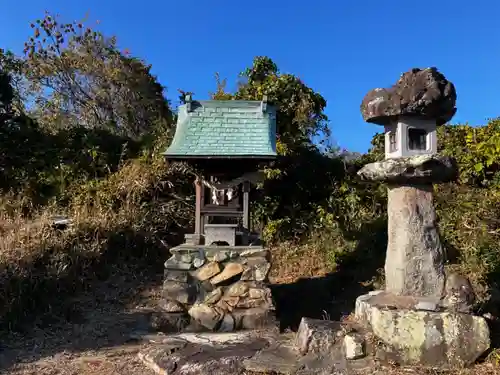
left=355, top=295, right=490, bottom=368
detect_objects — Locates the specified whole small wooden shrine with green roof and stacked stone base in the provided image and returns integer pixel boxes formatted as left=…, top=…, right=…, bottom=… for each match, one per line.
left=162, top=95, right=276, bottom=332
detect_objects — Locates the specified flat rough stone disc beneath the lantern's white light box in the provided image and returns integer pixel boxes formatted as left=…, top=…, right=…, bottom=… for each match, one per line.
left=358, top=155, right=458, bottom=184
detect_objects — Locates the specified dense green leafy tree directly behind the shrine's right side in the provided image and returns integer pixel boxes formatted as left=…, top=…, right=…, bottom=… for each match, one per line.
left=212, top=56, right=344, bottom=240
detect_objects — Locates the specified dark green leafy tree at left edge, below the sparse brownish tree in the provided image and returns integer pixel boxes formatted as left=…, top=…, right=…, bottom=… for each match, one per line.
left=0, top=48, right=144, bottom=204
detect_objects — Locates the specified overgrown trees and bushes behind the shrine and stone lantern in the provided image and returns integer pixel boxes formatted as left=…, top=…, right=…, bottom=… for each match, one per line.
left=0, top=14, right=500, bottom=332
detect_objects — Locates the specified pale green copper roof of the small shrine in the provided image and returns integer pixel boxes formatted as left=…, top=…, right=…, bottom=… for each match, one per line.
left=164, top=99, right=276, bottom=159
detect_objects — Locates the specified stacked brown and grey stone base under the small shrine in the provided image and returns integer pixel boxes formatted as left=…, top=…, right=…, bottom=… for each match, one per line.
left=160, top=244, right=276, bottom=332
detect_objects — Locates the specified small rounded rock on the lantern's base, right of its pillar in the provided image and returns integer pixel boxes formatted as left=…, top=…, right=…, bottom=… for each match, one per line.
left=442, top=273, right=476, bottom=313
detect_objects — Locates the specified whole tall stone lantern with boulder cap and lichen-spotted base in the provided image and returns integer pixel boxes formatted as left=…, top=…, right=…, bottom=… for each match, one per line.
left=355, top=68, right=490, bottom=368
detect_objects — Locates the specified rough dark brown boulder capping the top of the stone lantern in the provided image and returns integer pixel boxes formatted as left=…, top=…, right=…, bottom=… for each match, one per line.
left=361, top=68, right=457, bottom=125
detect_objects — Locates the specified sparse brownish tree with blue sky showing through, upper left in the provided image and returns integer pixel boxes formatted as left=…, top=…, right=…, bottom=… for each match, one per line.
left=23, top=13, right=172, bottom=137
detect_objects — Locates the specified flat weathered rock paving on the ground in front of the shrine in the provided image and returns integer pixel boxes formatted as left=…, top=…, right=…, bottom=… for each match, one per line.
left=139, top=330, right=376, bottom=375
